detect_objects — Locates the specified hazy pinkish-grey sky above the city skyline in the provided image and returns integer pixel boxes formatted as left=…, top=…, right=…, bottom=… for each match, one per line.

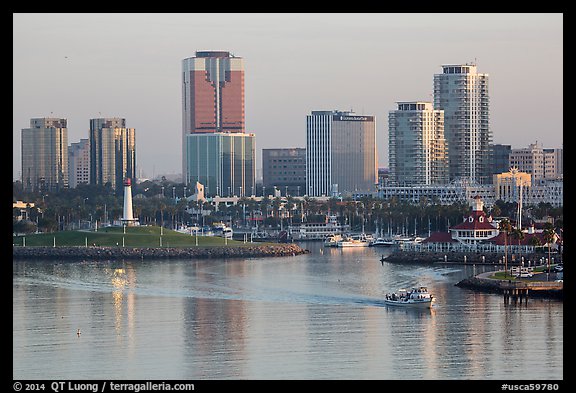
left=13, top=13, right=563, bottom=179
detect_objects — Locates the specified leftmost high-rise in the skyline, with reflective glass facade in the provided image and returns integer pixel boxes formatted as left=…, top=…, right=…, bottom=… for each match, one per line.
left=21, top=117, right=68, bottom=192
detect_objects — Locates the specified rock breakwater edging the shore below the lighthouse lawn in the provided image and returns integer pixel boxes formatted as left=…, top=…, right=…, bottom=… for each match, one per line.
left=12, top=243, right=309, bottom=260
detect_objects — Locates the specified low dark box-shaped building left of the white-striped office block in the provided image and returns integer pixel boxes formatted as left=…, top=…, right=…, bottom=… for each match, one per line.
left=262, top=147, right=306, bottom=196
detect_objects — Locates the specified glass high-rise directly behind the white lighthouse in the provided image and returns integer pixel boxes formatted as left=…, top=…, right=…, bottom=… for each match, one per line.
left=90, top=117, right=136, bottom=191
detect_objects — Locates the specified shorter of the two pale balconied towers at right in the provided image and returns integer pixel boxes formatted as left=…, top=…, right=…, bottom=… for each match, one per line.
left=388, top=101, right=448, bottom=185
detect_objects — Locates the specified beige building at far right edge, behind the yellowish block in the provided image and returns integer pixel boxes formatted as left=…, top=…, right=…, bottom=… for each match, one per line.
left=509, top=143, right=564, bottom=183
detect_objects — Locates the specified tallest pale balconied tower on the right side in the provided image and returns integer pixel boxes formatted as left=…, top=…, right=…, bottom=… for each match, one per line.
left=434, top=64, right=492, bottom=184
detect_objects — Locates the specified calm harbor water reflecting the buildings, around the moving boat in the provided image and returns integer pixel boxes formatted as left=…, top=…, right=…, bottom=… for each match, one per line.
left=13, top=243, right=564, bottom=381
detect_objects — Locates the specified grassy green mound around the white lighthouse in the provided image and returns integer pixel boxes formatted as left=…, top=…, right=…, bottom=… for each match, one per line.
left=12, top=226, right=264, bottom=247
